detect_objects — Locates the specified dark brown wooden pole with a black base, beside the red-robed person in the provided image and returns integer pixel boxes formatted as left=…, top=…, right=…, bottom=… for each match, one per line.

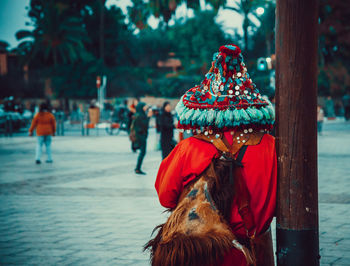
left=276, top=0, right=319, bottom=266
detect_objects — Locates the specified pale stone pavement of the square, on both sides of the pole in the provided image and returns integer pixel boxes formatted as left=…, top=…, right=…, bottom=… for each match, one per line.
left=0, top=122, right=350, bottom=265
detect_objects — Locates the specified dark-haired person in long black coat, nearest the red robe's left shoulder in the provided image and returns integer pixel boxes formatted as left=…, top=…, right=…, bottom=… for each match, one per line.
left=159, top=102, right=174, bottom=159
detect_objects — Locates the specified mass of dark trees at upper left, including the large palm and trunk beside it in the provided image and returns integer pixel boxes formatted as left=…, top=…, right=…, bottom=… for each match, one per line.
left=16, top=0, right=135, bottom=98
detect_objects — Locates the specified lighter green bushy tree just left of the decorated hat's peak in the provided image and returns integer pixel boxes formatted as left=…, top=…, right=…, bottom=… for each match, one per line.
left=128, top=11, right=230, bottom=97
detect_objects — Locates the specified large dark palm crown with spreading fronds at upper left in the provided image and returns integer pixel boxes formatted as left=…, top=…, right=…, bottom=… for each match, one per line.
left=16, top=0, right=89, bottom=67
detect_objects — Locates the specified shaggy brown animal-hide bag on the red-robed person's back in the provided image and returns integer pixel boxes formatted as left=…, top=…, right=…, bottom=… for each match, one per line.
left=144, top=160, right=253, bottom=266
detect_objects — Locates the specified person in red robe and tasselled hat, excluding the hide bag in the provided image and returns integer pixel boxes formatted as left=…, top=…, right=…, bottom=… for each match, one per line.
left=148, top=45, right=277, bottom=266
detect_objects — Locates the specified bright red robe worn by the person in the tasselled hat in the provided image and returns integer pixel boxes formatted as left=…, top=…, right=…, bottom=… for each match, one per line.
left=155, top=134, right=277, bottom=266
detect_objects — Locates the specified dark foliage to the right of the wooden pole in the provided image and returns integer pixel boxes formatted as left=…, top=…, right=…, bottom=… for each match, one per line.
left=318, top=0, right=350, bottom=97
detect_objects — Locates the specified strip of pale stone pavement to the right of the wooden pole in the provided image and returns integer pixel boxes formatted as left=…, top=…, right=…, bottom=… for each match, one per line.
left=318, top=121, right=350, bottom=266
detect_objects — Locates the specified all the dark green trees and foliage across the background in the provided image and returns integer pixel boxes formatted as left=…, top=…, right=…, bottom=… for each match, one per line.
left=14, top=0, right=350, bottom=98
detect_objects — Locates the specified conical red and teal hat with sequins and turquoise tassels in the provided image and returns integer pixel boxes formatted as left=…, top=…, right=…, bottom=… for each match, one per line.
left=176, top=44, right=275, bottom=134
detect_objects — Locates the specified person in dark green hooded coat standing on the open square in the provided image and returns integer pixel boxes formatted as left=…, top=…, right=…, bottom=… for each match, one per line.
left=131, top=102, right=152, bottom=175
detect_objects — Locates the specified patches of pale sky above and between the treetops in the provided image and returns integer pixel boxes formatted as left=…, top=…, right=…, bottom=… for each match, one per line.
left=0, top=0, right=246, bottom=48
